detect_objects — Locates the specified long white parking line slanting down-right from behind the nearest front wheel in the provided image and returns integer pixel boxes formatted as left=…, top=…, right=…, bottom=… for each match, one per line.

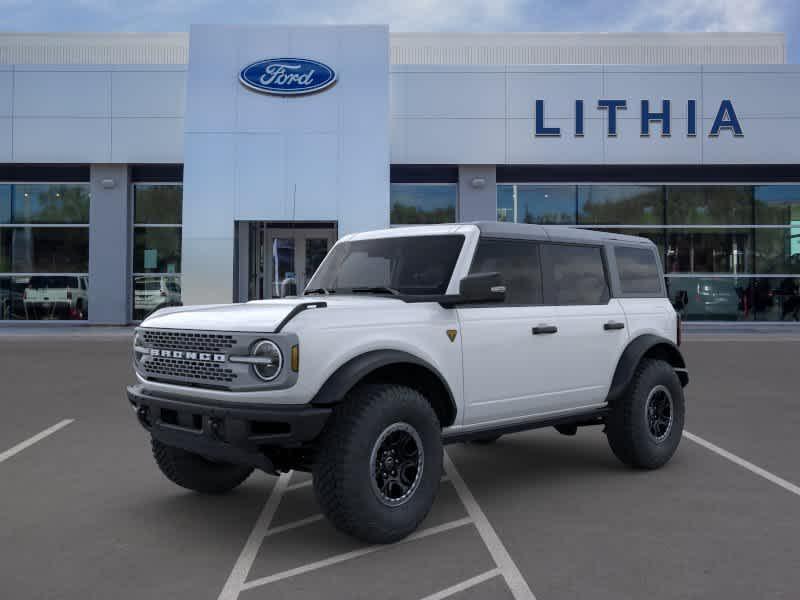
left=444, top=452, right=536, bottom=600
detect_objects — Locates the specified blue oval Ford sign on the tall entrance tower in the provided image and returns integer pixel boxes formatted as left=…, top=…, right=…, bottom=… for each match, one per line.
left=239, top=58, right=336, bottom=96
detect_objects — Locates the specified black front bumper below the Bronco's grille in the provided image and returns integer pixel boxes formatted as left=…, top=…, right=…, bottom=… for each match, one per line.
left=128, top=385, right=331, bottom=473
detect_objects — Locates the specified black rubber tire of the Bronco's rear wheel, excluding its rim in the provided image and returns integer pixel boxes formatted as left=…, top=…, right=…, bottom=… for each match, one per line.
left=606, top=359, right=685, bottom=469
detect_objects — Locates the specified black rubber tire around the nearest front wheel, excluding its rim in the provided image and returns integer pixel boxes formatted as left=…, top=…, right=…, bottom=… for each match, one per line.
left=313, top=384, right=443, bottom=544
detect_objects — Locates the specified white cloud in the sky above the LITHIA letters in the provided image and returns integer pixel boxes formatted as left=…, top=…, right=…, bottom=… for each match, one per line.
left=626, top=0, right=780, bottom=31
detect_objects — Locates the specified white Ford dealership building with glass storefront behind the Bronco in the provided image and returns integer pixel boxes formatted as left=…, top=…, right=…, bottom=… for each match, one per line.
left=0, top=25, right=800, bottom=324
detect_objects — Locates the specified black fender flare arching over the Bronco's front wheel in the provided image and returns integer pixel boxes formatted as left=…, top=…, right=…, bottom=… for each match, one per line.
left=311, top=350, right=458, bottom=426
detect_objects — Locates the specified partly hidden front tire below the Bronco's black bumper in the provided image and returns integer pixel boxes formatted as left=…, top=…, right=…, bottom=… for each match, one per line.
left=151, top=438, right=253, bottom=494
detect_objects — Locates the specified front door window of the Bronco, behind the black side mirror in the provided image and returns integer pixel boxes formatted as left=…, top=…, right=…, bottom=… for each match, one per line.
left=470, top=240, right=542, bottom=305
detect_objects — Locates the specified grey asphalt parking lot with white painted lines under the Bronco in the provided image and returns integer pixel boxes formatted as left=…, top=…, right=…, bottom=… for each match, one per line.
left=0, top=330, right=800, bottom=600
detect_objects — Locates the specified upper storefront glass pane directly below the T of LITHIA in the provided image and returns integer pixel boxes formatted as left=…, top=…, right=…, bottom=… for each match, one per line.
left=578, top=185, right=664, bottom=225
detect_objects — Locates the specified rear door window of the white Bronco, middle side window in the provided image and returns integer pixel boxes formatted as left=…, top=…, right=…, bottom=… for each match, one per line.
left=542, top=244, right=611, bottom=305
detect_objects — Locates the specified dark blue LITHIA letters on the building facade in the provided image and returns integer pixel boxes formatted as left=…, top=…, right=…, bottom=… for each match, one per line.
left=534, top=99, right=744, bottom=137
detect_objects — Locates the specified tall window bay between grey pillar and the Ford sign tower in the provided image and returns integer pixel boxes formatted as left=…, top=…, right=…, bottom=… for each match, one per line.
left=133, top=183, right=183, bottom=321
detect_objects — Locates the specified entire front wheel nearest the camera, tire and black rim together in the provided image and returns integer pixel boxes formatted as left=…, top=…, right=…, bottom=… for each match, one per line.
left=314, top=384, right=443, bottom=544
